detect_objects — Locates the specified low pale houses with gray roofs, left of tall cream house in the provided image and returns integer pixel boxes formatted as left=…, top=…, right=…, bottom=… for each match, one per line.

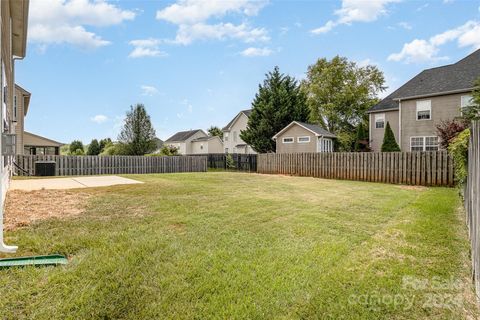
left=164, top=129, right=223, bottom=155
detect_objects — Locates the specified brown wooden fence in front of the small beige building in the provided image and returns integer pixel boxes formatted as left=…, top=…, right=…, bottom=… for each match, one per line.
left=257, top=151, right=454, bottom=186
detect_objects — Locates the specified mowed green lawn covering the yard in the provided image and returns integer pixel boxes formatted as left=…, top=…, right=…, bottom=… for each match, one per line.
left=0, top=172, right=477, bottom=319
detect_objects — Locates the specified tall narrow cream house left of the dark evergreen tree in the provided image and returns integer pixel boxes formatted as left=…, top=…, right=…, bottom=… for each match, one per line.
left=222, top=109, right=256, bottom=153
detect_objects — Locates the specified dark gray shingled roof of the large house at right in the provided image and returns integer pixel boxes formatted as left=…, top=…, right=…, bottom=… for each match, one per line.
left=370, top=49, right=480, bottom=112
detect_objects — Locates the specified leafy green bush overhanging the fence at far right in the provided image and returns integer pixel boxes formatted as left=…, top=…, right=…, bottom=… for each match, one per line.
left=448, top=129, right=470, bottom=185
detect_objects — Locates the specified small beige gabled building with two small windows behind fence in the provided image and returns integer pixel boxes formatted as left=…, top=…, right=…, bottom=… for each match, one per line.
left=273, top=121, right=335, bottom=153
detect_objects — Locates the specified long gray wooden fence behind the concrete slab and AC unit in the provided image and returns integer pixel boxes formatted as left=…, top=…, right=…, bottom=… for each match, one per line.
left=13, top=155, right=207, bottom=176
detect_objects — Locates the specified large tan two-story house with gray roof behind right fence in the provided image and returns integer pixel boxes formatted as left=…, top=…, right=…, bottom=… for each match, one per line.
left=369, top=50, right=480, bottom=151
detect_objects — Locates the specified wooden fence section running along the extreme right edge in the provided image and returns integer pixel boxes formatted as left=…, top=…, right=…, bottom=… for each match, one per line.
left=464, top=121, right=480, bottom=297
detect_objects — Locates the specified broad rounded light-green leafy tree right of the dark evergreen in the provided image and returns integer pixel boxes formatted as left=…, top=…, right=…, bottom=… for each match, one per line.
left=302, top=56, right=385, bottom=149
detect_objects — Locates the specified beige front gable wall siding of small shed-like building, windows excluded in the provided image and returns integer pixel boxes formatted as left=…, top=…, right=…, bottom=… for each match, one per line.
left=277, top=124, right=318, bottom=153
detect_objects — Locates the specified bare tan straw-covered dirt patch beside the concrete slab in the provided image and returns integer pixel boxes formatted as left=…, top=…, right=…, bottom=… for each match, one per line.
left=4, top=190, right=91, bottom=230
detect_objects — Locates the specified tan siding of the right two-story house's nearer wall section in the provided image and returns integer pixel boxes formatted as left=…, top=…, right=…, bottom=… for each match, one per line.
left=401, top=93, right=465, bottom=151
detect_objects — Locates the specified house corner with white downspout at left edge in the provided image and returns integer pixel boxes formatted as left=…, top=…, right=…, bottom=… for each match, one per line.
left=0, top=0, right=29, bottom=252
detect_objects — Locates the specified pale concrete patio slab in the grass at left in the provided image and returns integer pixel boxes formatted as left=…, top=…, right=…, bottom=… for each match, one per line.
left=10, top=176, right=143, bottom=191
